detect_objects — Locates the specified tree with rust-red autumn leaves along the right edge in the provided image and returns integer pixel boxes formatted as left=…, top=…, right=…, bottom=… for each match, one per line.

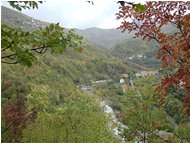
left=116, top=1, right=190, bottom=115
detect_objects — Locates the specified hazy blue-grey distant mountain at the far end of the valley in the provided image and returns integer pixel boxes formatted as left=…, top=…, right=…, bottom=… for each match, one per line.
left=76, top=24, right=177, bottom=50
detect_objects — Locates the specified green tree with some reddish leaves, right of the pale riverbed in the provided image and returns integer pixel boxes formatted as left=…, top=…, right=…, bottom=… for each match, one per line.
left=123, top=82, right=169, bottom=143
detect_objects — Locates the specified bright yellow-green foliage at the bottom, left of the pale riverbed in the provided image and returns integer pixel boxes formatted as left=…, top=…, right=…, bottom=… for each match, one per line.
left=22, top=92, right=114, bottom=143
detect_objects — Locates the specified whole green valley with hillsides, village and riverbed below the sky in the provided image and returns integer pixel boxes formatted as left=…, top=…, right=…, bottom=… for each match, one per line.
left=1, top=1, right=190, bottom=143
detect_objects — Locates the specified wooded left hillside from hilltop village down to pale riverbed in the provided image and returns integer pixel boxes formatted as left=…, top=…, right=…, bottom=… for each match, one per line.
left=1, top=7, right=136, bottom=142
